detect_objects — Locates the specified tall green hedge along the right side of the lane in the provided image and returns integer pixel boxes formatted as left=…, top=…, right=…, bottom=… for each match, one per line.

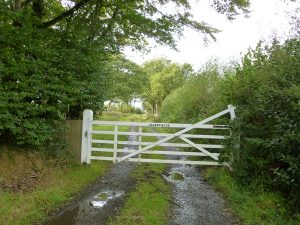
left=160, top=39, right=300, bottom=210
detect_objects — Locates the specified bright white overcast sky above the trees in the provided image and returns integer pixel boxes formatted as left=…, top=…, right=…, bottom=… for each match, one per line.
left=124, top=0, right=300, bottom=70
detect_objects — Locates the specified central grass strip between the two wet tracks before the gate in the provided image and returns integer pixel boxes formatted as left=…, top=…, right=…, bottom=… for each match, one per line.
left=109, top=164, right=171, bottom=225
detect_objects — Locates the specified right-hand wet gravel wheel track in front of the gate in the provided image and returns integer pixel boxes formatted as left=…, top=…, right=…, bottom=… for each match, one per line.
left=166, top=165, right=237, bottom=225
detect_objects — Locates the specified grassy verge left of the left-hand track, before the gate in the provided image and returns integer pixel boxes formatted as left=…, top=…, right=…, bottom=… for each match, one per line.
left=0, top=158, right=110, bottom=225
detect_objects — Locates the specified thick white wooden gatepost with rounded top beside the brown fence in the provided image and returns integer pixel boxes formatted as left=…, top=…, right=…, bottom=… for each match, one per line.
left=81, top=109, right=93, bottom=164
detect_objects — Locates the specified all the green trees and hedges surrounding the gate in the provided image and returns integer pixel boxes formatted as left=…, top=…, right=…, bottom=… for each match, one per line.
left=0, top=0, right=300, bottom=218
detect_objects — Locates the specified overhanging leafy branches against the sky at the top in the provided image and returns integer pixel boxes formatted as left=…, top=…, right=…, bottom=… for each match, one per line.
left=33, top=0, right=227, bottom=51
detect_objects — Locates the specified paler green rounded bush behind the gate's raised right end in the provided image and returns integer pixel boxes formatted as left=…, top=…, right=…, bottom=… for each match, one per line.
left=160, top=65, right=221, bottom=123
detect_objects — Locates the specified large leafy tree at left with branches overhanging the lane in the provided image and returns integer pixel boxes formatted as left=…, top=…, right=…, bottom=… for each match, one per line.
left=0, top=0, right=251, bottom=146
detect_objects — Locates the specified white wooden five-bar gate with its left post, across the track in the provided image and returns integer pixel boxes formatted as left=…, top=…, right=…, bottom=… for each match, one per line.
left=81, top=105, right=235, bottom=166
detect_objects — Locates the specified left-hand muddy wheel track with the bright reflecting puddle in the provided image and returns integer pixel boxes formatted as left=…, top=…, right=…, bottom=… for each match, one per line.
left=42, top=128, right=136, bottom=225
